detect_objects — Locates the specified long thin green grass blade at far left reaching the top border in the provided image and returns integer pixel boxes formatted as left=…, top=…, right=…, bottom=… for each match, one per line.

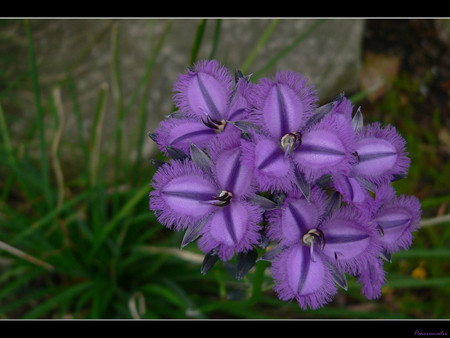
left=24, top=20, right=53, bottom=209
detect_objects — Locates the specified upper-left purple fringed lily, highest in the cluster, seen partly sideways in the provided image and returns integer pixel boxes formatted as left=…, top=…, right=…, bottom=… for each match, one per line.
left=154, top=60, right=252, bottom=154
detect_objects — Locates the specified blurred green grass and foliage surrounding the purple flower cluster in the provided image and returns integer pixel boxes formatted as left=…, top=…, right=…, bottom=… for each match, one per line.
left=0, top=19, right=450, bottom=319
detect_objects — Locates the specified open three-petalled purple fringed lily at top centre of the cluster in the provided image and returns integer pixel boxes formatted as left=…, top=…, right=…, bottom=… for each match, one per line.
left=243, top=72, right=354, bottom=197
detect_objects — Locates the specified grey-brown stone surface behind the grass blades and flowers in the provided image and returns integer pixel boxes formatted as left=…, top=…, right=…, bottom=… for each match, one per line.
left=0, top=18, right=364, bottom=162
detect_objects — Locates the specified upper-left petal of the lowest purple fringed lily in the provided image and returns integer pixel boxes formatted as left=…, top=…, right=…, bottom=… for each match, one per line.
left=266, top=187, right=327, bottom=246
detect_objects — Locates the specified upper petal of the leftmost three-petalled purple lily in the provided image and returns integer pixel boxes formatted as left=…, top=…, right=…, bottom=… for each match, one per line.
left=208, top=131, right=255, bottom=198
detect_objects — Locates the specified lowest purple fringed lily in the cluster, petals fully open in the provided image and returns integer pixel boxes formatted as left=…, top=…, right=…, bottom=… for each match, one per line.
left=267, top=187, right=381, bottom=309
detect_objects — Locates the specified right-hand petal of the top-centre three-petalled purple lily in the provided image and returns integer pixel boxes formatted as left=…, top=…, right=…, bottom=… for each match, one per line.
left=292, top=114, right=355, bottom=182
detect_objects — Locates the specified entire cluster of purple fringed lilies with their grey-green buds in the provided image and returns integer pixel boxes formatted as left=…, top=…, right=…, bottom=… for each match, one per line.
left=150, top=60, right=421, bottom=309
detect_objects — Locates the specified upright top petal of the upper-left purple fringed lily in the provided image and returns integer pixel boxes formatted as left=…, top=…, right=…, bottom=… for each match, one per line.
left=174, top=60, right=233, bottom=121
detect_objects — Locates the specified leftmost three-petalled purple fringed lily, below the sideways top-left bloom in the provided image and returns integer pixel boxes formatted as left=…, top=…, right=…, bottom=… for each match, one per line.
left=150, top=138, right=262, bottom=261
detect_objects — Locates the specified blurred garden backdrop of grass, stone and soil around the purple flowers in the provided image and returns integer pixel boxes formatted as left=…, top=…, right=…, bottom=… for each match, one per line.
left=0, top=18, right=450, bottom=319
